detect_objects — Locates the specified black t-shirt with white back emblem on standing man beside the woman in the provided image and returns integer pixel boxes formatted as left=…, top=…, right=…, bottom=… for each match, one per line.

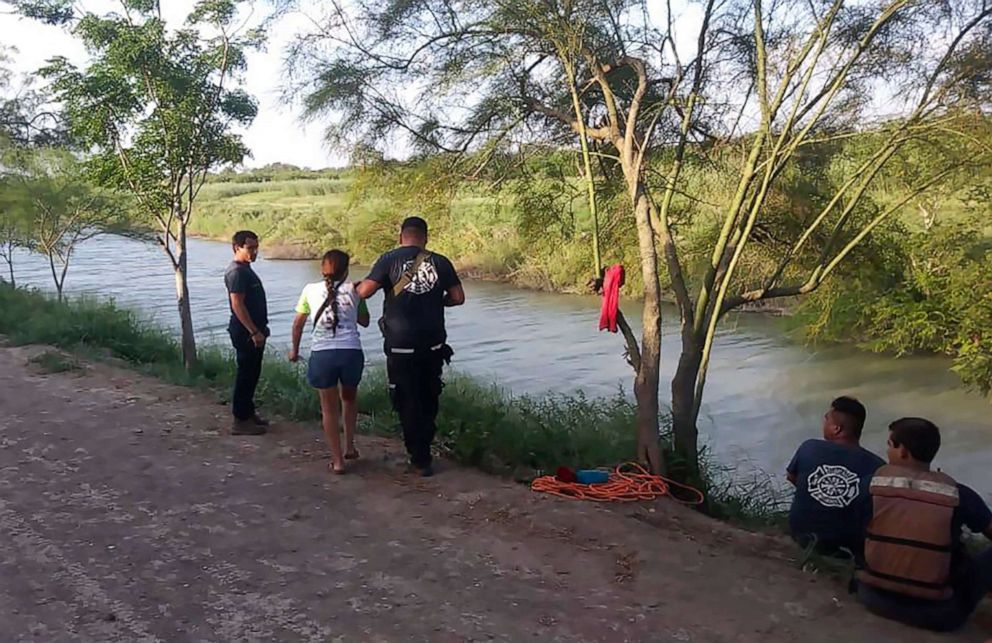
left=368, top=246, right=461, bottom=350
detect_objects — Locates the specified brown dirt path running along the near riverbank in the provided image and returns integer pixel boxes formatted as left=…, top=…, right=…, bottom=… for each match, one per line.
left=0, top=348, right=984, bottom=643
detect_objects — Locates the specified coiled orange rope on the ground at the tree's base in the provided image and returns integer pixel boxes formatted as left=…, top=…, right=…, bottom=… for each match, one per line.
left=530, top=462, right=704, bottom=505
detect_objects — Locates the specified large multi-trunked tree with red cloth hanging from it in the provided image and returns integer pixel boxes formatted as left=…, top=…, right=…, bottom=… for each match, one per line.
left=291, top=0, right=992, bottom=477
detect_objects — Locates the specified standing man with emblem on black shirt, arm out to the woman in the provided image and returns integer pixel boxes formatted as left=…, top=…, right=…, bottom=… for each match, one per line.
left=358, top=217, right=465, bottom=476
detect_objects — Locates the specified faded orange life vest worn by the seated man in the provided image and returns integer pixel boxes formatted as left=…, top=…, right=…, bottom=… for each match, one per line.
left=858, top=464, right=960, bottom=600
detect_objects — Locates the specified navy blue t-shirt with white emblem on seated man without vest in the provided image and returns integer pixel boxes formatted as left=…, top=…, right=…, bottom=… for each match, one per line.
left=786, top=440, right=885, bottom=542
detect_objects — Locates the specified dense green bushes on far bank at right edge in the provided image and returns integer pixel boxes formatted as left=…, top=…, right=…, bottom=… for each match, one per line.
left=793, top=209, right=992, bottom=394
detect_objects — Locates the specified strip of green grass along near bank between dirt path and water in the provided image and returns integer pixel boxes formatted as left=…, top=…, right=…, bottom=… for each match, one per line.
left=0, top=284, right=782, bottom=526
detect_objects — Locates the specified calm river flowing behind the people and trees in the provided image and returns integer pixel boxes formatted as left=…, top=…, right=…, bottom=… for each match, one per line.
left=9, top=237, right=992, bottom=496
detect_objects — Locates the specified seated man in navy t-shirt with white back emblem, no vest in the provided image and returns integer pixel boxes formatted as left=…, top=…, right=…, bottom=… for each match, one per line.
left=786, top=397, right=885, bottom=561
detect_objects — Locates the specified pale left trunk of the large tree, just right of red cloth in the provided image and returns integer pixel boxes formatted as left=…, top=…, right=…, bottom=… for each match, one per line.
left=634, top=190, right=664, bottom=473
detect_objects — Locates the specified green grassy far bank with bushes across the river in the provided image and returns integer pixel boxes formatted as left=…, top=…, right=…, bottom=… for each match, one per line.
left=193, top=166, right=992, bottom=399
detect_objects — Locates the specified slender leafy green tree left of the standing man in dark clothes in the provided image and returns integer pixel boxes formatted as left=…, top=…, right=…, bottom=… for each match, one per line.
left=21, top=0, right=262, bottom=369
